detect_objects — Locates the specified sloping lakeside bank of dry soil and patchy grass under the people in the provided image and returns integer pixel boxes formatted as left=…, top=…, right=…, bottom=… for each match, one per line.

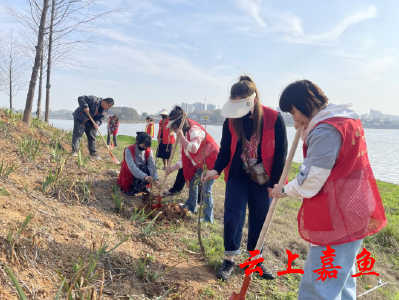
left=0, top=110, right=399, bottom=300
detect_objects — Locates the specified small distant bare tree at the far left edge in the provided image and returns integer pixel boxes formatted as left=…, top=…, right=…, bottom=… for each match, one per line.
left=0, top=30, right=28, bottom=110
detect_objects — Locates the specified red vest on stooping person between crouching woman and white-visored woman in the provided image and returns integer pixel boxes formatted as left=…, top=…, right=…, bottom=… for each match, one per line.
left=182, top=119, right=219, bottom=181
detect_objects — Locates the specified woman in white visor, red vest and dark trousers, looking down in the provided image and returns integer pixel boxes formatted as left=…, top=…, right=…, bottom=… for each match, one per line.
left=203, top=76, right=288, bottom=281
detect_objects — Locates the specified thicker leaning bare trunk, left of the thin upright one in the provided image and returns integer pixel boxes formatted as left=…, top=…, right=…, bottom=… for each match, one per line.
left=23, top=0, right=49, bottom=125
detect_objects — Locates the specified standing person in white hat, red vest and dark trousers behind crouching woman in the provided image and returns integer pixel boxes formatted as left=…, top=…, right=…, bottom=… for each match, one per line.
left=157, top=109, right=175, bottom=170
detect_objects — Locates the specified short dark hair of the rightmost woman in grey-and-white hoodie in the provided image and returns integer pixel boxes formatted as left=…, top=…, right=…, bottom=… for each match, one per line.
left=279, top=80, right=328, bottom=118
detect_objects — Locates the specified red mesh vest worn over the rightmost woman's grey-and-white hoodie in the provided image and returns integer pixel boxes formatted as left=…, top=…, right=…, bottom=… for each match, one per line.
left=298, top=118, right=387, bottom=246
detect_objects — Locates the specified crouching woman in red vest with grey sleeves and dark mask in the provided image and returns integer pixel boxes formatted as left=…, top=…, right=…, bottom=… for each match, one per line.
left=117, top=133, right=159, bottom=196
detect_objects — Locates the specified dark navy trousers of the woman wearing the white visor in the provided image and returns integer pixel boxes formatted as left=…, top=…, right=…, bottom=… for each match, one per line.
left=224, top=172, right=273, bottom=255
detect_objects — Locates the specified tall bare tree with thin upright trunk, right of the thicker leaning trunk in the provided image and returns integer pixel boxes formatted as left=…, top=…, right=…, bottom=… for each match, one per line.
left=3, top=0, right=125, bottom=122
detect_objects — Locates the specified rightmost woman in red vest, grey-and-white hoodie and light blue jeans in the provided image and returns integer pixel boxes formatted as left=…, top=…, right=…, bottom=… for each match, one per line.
left=271, top=80, right=387, bottom=300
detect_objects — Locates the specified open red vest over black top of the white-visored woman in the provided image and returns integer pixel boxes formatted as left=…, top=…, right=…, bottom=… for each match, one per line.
left=224, top=105, right=278, bottom=182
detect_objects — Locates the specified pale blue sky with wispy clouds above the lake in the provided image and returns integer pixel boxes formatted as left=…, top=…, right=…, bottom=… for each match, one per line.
left=0, top=0, right=399, bottom=115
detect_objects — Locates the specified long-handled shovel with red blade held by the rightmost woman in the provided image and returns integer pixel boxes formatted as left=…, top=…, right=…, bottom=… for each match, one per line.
left=229, top=128, right=302, bottom=300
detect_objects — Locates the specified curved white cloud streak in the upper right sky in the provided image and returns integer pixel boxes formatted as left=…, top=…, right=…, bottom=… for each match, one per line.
left=288, top=6, right=378, bottom=44
